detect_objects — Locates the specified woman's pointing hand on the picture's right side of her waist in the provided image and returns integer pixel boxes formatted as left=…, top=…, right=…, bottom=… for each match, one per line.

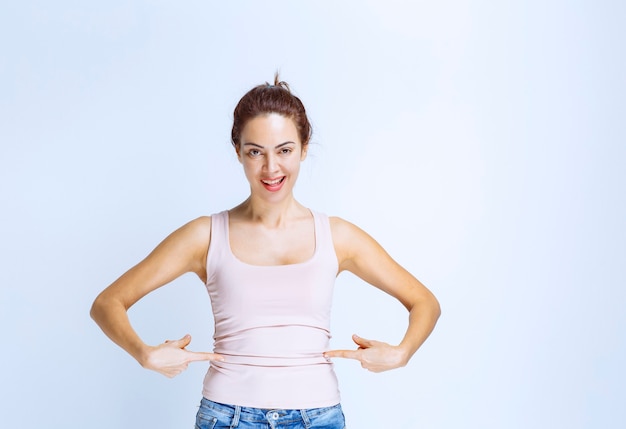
left=324, top=335, right=407, bottom=372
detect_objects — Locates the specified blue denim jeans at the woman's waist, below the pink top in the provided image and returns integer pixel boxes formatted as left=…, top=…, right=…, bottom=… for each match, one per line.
left=195, top=398, right=346, bottom=429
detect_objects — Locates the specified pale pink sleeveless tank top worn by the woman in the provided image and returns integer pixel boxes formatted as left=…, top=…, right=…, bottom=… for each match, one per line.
left=202, top=211, right=340, bottom=409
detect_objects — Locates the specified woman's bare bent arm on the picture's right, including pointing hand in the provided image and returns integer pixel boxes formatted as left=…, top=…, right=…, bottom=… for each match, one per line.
left=325, top=218, right=441, bottom=372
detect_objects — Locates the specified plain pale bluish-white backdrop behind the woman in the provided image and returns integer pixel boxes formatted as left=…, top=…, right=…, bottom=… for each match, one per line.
left=0, top=0, right=626, bottom=429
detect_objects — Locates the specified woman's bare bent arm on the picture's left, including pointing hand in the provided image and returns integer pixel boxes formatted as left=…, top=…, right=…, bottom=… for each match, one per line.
left=91, top=217, right=222, bottom=377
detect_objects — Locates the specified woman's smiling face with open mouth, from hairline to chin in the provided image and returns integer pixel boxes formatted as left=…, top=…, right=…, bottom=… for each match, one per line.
left=237, top=113, right=306, bottom=200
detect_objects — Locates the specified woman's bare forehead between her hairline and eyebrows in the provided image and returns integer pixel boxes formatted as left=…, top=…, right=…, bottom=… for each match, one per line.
left=241, top=113, right=300, bottom=144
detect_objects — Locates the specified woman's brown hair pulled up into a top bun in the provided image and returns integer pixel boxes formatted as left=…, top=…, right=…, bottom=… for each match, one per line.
left=231, top=73, right=312, bottom=147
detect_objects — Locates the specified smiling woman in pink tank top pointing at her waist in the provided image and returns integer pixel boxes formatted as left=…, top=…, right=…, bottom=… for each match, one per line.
left=91, top=76, right=440, bottom=429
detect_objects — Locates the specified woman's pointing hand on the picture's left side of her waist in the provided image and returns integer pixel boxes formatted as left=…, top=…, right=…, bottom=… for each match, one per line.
left=141, top=335, right=224, bottom=378
